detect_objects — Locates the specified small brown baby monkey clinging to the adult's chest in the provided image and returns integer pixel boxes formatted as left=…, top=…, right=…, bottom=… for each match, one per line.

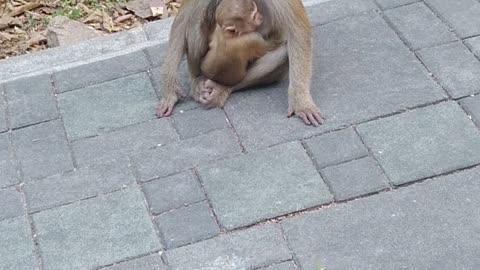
left=201, top=0, right=273, bottom=86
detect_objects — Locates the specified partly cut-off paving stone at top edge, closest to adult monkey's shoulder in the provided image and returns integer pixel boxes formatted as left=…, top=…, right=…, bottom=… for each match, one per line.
left=307, top=0, right=377, bottom=26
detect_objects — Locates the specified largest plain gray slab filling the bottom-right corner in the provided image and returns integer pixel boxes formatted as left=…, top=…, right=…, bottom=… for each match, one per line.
left=283, top=168, right=480, bottom=270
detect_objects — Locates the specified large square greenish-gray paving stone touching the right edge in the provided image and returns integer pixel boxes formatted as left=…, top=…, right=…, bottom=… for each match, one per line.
left=358, top=102, right=480, bottom=185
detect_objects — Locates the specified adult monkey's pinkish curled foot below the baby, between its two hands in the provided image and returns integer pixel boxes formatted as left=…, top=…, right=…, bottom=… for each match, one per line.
left=194, top=79, right=230, bottom=109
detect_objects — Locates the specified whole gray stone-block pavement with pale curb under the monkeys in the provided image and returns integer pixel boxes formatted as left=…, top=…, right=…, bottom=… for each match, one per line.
left=0, top=0, right=480, bottom=270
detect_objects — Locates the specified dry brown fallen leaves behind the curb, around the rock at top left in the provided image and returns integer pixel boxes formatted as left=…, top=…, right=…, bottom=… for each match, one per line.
left=0, top=0, right=182, bottom=59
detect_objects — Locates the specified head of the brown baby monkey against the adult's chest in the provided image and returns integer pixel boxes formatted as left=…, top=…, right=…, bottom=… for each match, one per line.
left=215, top=0, right=263, bottom=37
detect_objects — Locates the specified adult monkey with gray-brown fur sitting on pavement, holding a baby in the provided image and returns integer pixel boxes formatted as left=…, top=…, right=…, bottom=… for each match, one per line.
left=157, top=0, right=323, bottom=126
